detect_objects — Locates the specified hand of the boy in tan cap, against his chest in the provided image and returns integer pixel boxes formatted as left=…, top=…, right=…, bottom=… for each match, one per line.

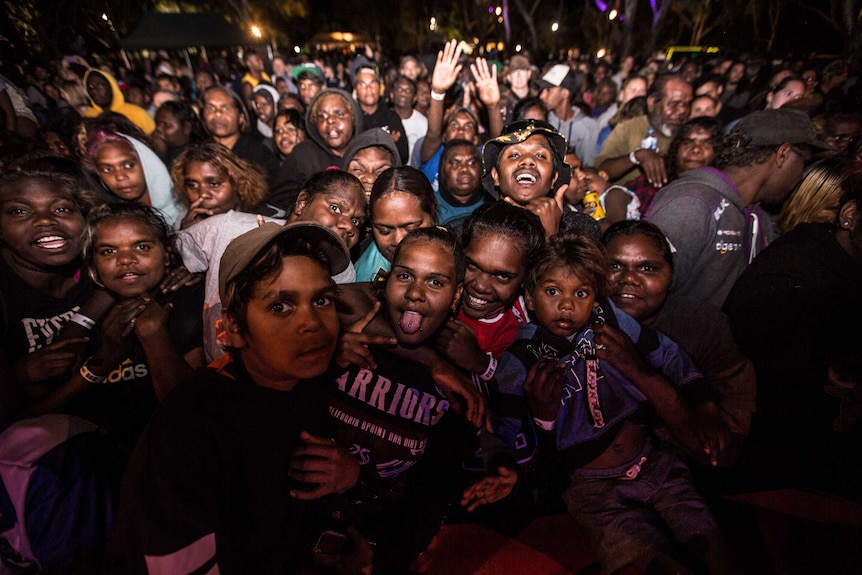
left=288, top=431, right=359, bottom=500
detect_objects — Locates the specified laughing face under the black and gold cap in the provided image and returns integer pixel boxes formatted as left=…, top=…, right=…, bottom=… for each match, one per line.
left=491, top=134, right=557, bottom=206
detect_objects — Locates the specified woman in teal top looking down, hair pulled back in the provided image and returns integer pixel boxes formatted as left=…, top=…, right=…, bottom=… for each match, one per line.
left=356, top=166, right=437, bottom=282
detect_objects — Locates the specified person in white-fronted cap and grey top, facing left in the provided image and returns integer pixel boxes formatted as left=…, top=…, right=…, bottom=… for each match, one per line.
left=537, top=64, right=599, bottom=166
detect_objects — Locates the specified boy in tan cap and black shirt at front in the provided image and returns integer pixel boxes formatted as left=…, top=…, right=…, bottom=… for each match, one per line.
left=118, top=223, right=359, bottom=573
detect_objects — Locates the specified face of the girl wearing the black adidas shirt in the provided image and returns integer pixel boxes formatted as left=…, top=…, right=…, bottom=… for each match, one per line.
left=93, top=218, right=170, bottom=299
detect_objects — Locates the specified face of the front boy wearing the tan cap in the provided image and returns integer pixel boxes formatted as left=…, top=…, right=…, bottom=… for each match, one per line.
left=225, top=256, right=338, bottom=391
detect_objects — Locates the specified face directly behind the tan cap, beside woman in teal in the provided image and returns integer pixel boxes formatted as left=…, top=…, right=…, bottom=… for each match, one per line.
left=293, top=185, right=366, bottom=248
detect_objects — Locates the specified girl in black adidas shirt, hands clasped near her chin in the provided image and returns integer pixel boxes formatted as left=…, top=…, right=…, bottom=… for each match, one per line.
left=72, top=203, right=204, bottom=449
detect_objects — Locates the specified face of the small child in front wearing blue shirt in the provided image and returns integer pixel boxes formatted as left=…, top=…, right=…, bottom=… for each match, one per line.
left=526, top=268, right=597, bottom=337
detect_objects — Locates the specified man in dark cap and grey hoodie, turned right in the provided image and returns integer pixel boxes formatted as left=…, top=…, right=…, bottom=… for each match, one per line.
left=646, top=108, right=823, bottom=307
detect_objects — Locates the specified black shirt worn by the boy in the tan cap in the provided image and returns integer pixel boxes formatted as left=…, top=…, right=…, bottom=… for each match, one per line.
left=117, top=355, right=338, bottom=574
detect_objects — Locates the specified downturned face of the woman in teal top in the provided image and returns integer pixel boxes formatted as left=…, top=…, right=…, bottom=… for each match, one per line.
left=371, top=190, right=434, bottom=262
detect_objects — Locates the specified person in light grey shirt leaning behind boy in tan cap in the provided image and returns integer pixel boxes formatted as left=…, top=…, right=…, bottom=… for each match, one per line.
left=178, top=170, right=366, bottom=361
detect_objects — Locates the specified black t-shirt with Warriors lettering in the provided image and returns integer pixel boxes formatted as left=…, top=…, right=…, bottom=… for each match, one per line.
left=329, top=350, right=476, bottom=573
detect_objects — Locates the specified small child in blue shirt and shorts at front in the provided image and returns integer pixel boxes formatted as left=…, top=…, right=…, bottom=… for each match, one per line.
left=486, top=236, right=727, bottom=573
